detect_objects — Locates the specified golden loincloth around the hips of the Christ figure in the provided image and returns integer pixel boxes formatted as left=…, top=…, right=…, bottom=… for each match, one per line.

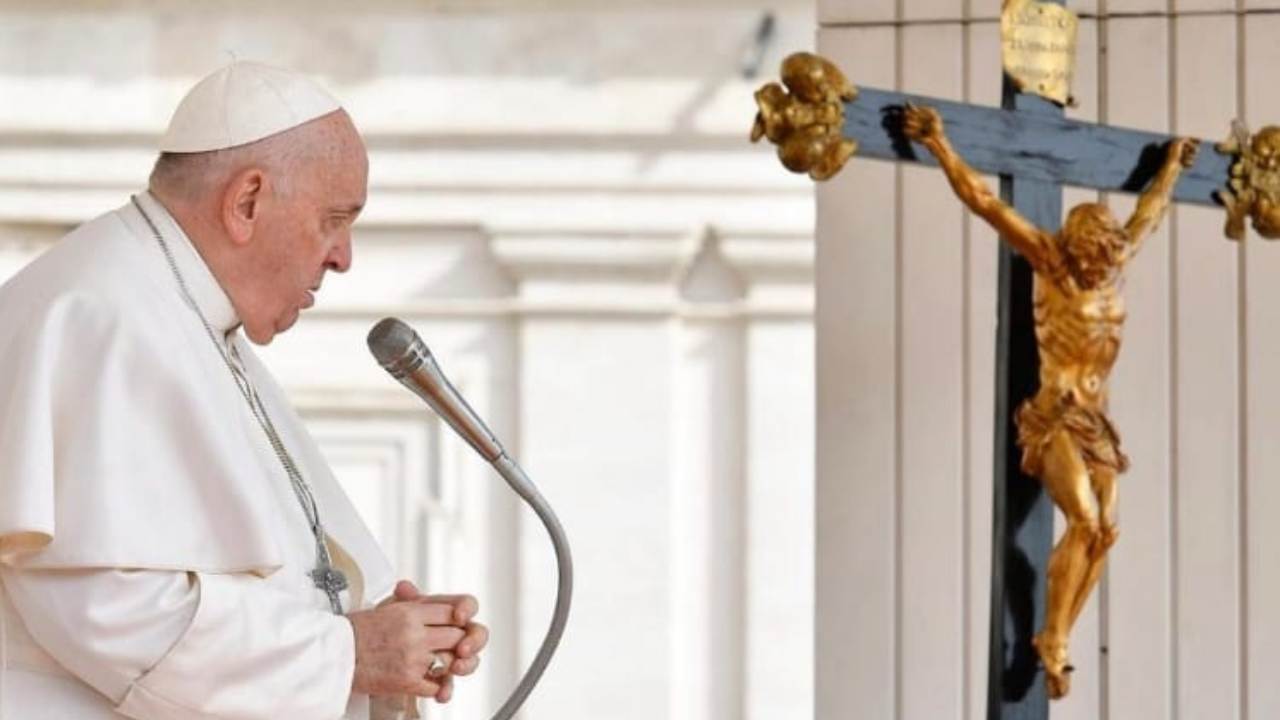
left=1015, top=395, right=1129, bottom=478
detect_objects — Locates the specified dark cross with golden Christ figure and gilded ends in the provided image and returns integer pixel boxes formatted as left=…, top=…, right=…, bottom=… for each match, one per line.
left=753, top=3, right=1280, bottom=720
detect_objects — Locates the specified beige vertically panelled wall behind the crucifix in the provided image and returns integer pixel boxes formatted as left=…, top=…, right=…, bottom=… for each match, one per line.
left=817, top=0, right=1280, bottom=720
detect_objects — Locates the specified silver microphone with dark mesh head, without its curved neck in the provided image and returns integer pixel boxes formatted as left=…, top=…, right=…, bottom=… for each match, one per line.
left=369, top=318, right=506, bottom=462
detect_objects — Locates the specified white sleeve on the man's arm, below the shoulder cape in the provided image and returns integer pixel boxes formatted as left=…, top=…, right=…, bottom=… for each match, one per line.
left=0, top=569, right=355, bottom=720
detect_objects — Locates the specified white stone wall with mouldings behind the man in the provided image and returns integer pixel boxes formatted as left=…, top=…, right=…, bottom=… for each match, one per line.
left=0, top=0, right=814, bottom=720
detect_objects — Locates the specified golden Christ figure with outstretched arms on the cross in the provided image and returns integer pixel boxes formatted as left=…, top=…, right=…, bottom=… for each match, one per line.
left=904, top=105, right=1199, bottom=698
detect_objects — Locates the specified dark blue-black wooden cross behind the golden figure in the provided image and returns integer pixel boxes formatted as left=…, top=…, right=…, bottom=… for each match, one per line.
left=757, top=0, right=1233, bottom=720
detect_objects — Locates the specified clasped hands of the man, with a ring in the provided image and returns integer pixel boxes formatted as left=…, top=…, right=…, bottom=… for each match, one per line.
left=347, top=580, right=489, bottom=703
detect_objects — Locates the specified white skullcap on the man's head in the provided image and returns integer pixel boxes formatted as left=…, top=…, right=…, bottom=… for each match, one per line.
left=160, top=60, right=342, bottom=152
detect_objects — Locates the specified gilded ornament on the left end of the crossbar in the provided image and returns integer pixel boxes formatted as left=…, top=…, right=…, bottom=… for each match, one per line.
left=751, top=53, right=858, bottom=181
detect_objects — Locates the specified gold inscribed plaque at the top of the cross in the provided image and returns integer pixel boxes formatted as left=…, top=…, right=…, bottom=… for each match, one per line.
left=1000, top=0, right=1078, bottom=105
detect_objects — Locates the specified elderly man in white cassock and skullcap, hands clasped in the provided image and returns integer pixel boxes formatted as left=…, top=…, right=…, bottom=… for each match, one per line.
left=0, top=63, right=486, bottom=720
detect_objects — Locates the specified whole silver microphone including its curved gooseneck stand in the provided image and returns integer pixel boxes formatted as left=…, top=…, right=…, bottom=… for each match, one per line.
left=369, top=318, right=573, bottom=720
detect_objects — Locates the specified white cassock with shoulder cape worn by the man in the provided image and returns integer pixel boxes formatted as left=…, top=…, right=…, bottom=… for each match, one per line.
left=0, top=193, right=404, bottom=720
